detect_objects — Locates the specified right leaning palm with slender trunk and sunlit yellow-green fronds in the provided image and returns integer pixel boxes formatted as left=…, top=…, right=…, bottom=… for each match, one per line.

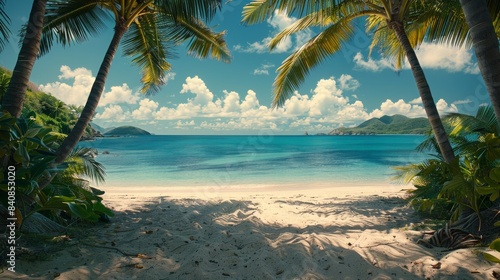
left=242, top=0, right=455, bottom=162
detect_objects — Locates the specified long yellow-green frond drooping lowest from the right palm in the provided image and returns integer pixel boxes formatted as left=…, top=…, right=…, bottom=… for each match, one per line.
left=273, top=17, right=354, bottom=107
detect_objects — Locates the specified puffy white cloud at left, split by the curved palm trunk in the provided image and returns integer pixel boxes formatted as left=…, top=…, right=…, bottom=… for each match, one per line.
left=40, top=65, right=143, bottom=106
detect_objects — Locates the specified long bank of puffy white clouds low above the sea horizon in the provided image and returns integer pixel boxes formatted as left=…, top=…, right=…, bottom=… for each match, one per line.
left=89, top=74, right=457, bottom=132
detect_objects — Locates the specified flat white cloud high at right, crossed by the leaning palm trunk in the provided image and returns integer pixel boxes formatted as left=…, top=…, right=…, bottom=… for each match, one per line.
left=353, top=43, right=479, bottom=74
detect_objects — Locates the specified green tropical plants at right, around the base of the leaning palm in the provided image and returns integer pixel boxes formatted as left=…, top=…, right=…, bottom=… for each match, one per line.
left=397, top=106, right=500, bottom=246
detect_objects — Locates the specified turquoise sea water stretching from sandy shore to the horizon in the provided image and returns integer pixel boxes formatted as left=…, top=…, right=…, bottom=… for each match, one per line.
left=83, top=135, right=426, bottom=187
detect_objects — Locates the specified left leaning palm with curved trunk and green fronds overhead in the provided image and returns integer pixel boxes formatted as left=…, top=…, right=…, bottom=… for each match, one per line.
left=41, top=0, right=230, bottom=164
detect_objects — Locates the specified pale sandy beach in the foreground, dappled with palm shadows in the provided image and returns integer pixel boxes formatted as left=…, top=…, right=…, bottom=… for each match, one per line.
left=4, top=185, right=500, bottom=279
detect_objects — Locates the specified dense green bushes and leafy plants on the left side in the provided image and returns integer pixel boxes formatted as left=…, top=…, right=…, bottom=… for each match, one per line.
left=0, top=80, right=113, bottom=233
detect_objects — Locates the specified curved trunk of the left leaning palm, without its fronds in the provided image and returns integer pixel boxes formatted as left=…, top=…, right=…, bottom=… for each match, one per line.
left=55, top=24, right=127, bottom=164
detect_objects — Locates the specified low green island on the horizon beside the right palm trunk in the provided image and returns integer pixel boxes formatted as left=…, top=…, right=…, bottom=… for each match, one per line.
left=327, top=115, right=431, bottom=135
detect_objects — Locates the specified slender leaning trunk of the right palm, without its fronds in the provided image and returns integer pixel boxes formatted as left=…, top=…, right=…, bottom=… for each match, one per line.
left=389, top=21, right=455, bottom=163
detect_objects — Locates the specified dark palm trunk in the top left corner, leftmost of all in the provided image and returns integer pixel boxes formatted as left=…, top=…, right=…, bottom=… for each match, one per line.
left=2, top=0, right=47, bottom=118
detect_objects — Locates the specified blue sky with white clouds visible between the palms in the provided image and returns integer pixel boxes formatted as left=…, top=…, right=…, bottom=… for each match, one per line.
left=0, top=0, right=489, bottom=134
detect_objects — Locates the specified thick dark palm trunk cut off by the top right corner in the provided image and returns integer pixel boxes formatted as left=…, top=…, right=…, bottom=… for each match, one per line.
left=460, top=0, right=500, bottom=123
